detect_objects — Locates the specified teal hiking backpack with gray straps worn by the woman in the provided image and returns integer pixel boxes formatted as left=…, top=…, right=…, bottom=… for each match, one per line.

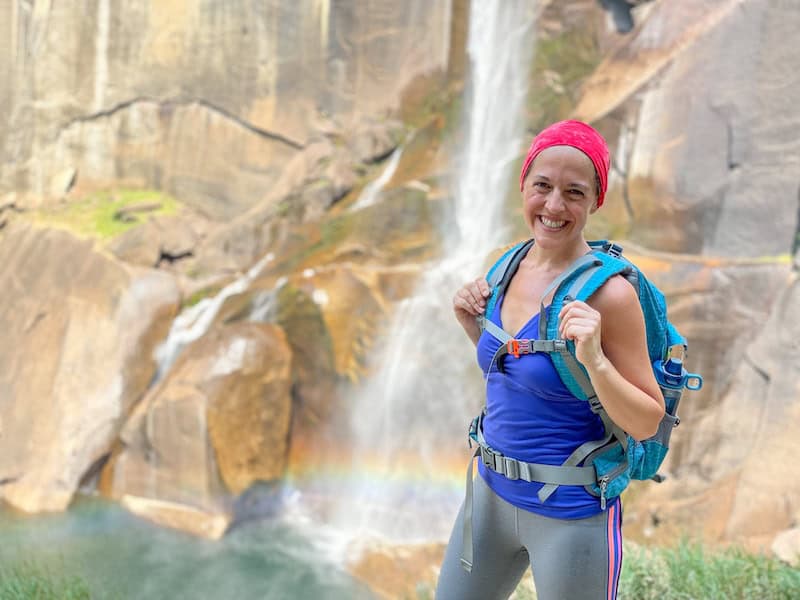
left=462, top=240, right=703, bottom=570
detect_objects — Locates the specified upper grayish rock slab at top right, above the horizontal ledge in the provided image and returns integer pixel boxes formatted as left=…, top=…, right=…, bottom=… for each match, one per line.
left=576, top=0, right=800, bottom=257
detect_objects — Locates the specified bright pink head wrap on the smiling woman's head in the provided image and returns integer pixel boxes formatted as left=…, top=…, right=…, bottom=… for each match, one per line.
left=519, top=121, right=611, bottom=208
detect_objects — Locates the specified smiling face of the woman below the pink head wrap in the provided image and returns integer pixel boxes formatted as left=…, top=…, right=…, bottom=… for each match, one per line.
left=522, top=146, right=597, bottom=248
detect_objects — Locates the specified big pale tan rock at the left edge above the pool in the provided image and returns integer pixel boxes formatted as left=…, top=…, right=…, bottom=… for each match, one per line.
left=0, top=223, right=179, bottom=512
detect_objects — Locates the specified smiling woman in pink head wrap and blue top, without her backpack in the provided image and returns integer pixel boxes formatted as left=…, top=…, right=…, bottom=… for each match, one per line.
left=436, top=121, right=664, bottom=600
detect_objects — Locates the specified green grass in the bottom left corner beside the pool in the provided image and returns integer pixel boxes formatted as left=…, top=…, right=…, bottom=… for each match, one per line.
left=0, top=562, right=91, bottom=600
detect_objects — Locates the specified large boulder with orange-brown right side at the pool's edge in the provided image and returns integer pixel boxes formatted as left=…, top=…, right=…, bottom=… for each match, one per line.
left=101, top=323, right=292, bottom=538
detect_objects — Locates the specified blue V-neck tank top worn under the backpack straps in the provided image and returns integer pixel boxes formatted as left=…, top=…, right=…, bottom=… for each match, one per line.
left=477, top=296, right=604, bottom=519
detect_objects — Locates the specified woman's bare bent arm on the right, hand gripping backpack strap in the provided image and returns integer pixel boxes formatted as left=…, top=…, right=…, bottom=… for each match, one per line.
left=559, top=276, right=664, bottom=440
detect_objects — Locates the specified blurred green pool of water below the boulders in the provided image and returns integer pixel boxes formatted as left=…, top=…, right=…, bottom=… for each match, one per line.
left=0, top=498, right=375, bottom=600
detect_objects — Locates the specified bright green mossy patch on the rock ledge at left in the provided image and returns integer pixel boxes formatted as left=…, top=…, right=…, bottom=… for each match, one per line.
left=34, top=189, right=179, bottom=240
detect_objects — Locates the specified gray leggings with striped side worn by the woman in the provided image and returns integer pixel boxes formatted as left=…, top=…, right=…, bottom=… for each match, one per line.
left=436, top=476, right=622, bottom=600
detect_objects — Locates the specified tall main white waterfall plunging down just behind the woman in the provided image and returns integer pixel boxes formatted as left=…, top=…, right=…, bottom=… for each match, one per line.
left=324, top=0, right=536, bottom=542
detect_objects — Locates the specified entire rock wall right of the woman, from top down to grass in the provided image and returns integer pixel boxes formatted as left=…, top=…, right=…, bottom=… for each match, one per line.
left=575, top=1, right=800, bottom=547
